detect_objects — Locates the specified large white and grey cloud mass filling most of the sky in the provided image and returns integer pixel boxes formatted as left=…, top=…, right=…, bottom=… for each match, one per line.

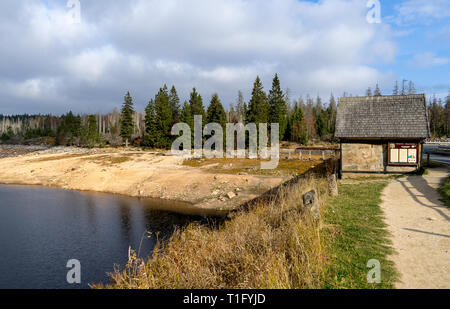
left=0, top=0, right=396, bottom=113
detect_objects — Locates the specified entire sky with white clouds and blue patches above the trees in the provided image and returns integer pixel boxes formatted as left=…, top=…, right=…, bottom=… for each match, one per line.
left=0, top=0, right=450, bottom=115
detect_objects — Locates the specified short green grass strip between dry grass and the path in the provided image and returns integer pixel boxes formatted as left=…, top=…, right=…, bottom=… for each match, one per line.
left=323, top=182, right=396, bottom=289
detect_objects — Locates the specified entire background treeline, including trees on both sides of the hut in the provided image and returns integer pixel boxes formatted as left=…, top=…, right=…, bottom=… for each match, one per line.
left=0, top=75, right=450, bottom=148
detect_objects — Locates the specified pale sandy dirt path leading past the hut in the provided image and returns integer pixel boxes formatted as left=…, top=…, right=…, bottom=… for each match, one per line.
left=381, top=168, right=450, bottom=289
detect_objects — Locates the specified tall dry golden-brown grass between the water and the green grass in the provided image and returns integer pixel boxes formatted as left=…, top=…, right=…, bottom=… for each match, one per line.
left=97, top=179, right=328, bottom=289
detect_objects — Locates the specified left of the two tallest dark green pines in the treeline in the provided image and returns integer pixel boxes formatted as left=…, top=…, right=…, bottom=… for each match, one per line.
left=245, top=76, right=269, bottom=127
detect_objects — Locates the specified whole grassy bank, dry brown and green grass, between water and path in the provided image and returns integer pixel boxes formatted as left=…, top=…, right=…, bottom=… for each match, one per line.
left=98, top=171, right=396, bottom=289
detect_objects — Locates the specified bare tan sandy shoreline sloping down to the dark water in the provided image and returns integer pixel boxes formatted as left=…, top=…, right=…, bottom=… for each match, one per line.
left=0, top=145, right=289, bottom=209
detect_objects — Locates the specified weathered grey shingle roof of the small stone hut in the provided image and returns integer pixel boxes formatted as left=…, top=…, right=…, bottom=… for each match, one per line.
left=336, top=94, right=430, bottom=138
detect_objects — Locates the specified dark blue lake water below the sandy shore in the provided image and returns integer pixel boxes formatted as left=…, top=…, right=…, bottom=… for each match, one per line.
left=0, top=185, right=199, bottom=289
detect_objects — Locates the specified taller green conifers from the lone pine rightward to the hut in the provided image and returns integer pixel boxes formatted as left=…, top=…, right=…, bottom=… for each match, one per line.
left=120, top=75, right=336, bottom=148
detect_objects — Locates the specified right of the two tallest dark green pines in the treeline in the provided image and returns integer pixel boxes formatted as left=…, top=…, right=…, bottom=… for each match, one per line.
left=268, top=74, right=287, bottom=140
